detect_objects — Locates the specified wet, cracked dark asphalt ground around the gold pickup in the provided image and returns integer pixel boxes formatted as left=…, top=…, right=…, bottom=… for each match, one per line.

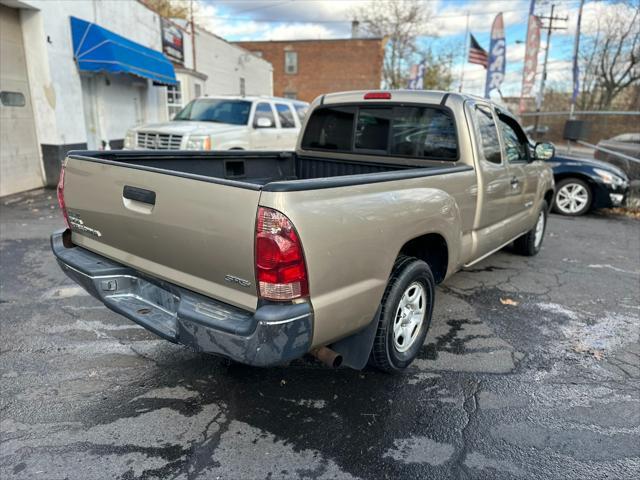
left=0, top=191, right=640, bottom=479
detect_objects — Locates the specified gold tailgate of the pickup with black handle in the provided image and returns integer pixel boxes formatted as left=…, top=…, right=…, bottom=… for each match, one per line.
left=64, top=157, right=260, bottom=311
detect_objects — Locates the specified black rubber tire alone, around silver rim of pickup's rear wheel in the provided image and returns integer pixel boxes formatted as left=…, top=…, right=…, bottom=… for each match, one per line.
left=369, top=255, right=435, bottom=373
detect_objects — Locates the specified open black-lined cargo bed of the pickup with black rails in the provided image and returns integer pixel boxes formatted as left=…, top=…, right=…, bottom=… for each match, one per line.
left=69, top=151, right=459, bottom=191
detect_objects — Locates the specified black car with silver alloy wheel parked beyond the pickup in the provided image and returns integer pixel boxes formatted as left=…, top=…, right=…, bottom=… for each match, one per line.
left=547, top=153, right=629, bottom=216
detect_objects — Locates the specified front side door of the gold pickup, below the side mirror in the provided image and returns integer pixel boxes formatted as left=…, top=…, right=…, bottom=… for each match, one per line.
left=498, top=114, right=537, bottom=240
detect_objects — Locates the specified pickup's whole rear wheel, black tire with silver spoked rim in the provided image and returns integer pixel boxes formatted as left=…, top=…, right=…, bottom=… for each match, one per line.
left=370, top=256, right=435, bottom=372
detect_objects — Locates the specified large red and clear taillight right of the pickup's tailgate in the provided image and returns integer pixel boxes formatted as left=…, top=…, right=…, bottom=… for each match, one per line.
left=256, top=207, right=309, bottom=300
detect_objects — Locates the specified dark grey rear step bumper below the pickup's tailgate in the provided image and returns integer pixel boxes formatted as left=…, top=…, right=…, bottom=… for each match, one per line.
left=51, top=230, right=313, bottom=366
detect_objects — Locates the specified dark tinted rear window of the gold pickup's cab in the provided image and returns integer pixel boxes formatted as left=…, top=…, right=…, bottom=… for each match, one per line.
left=302, top=106, right=458, bottom=160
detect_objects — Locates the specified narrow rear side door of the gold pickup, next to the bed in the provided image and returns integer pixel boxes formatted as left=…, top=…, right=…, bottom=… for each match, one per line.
left=470, top=103, right=511, bottom=258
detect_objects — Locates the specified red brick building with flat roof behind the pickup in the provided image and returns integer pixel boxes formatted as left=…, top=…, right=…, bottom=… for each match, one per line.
left=237, top=38, right=384, bottom=102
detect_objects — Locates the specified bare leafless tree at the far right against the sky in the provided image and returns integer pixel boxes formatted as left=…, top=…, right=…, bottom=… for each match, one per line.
left=580, top=0, right=640, bottom=110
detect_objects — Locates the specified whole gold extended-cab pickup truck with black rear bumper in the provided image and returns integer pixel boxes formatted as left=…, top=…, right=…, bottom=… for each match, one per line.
left=51, top=91, right=554, bottom=372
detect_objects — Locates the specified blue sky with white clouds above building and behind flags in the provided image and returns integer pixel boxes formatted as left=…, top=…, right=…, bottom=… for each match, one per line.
left=197, top=0, right=636, bottom=96
